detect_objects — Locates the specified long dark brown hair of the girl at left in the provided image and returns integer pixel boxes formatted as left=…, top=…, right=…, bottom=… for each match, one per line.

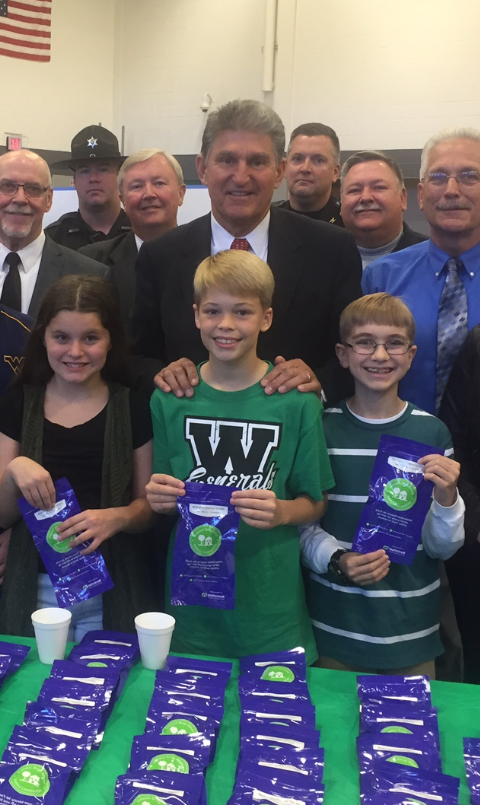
left=15, top=274, right=130, bottom=386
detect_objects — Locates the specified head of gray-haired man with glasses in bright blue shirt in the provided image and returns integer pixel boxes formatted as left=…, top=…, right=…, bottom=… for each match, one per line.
left=418, top=137, right=480, bottom=256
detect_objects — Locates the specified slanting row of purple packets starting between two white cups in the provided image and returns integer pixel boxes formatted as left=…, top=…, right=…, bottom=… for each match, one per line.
left=0, top=631, right=139, bottom=805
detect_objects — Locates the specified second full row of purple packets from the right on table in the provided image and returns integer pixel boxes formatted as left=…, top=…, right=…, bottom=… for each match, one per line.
left=229, top=648, right=324, bottom=805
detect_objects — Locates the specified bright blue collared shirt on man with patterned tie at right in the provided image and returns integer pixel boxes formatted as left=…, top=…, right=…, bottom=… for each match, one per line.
left=362, top=240, right=480, bottom=414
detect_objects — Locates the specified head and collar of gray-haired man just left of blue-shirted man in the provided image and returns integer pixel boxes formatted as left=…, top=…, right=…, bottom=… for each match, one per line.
left=340, top=151, right=427, bottom=268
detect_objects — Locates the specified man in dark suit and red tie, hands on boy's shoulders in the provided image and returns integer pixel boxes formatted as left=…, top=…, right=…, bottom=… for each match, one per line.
left=133, top=101, right=361, bottom=400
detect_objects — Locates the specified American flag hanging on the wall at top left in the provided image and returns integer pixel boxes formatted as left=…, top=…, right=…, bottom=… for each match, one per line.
left=0, top=0, right=52, bottom=61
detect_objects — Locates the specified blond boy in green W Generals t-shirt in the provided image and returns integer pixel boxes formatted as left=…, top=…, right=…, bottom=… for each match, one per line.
left=147, top=251, right=333, bottom=662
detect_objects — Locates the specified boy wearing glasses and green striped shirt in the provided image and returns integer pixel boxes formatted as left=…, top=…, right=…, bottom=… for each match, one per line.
left=301, top=293, right=465, bottom=677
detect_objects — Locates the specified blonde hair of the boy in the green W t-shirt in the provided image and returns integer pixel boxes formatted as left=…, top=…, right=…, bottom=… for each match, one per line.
left=193, top=249, right=275, bottom=310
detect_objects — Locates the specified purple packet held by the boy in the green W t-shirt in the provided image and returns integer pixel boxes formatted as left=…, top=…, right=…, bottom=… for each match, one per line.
left=171, top=481, right=240, bottom=609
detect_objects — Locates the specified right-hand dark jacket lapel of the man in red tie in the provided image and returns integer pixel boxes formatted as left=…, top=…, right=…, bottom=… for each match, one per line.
left=267, top=207, right=304, bottom=327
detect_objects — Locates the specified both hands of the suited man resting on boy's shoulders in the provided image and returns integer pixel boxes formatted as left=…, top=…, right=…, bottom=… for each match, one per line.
left=154, top=355, right=322, bottom=397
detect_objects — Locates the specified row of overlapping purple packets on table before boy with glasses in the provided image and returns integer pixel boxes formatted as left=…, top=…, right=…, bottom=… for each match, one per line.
left=357, top=675, right=460, bottom=805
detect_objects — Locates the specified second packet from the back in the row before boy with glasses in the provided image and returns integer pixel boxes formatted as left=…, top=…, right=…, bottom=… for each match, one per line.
left=360, top=702, right=440, bottom=747
